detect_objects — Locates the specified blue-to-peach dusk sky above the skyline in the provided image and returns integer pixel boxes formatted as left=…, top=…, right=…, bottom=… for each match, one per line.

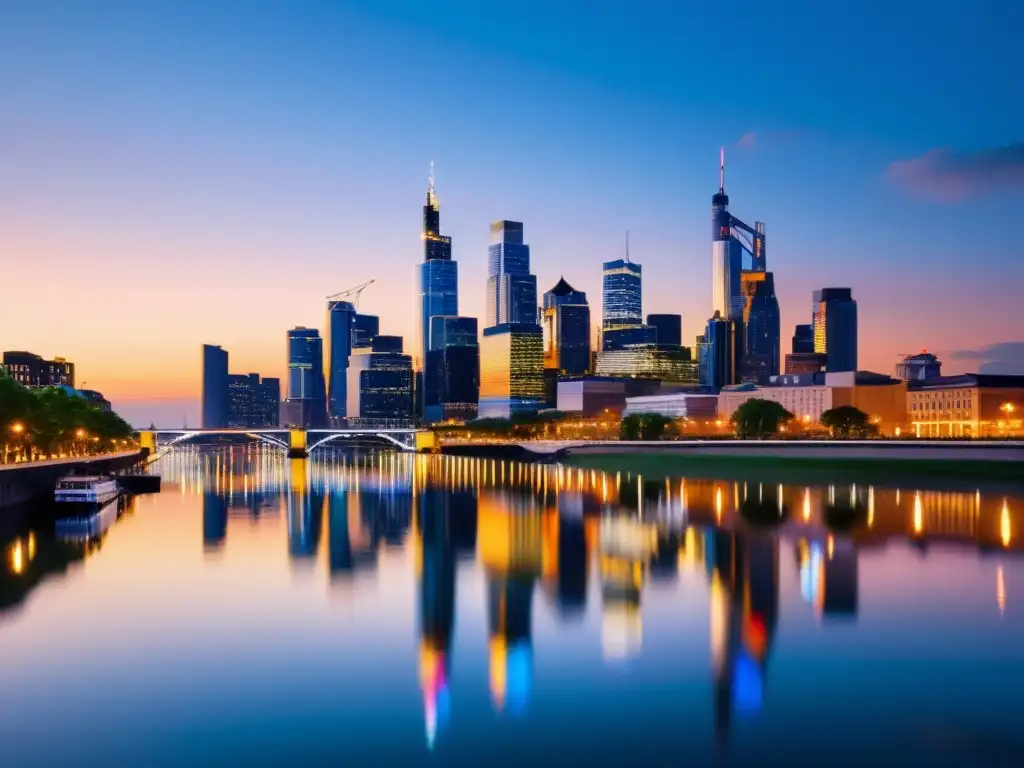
left=0, top=0, right=1024, bottom=426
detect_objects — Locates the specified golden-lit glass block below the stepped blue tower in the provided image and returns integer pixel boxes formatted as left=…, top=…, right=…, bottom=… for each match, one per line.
left=479, top=323, right=545, bottom=419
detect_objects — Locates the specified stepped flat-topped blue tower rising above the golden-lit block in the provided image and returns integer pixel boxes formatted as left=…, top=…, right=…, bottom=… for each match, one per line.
left=485, top=221, right=537, bottom=328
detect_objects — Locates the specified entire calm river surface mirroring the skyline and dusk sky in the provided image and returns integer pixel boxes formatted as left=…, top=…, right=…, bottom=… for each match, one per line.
left=0, top=447, right=1024, bottom=766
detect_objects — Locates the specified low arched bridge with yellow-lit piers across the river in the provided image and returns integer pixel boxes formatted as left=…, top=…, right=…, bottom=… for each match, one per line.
left=139, top=427, right=435, bottom=459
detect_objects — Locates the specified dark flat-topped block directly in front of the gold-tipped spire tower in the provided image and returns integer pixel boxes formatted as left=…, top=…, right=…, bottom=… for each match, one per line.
left=424, top=315, right=480, bottom=424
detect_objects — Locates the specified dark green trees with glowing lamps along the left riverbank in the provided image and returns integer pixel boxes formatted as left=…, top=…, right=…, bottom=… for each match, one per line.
left=0, top=370, right=132, bottom=461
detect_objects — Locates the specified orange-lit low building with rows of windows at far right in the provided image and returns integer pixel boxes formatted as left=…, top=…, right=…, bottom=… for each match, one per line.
left=906, top=374, right=1024, bottom=437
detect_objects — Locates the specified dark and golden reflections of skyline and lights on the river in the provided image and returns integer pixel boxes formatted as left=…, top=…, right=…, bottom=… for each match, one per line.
left=0, top=447, right=1024, bottom=765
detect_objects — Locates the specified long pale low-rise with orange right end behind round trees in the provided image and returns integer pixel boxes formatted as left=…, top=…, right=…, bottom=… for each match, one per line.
left=718, top=371, right=907, bottom=435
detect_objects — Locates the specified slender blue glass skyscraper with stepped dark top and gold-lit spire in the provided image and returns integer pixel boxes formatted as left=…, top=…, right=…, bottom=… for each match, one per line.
left=416, top=163, right=459, bottom=414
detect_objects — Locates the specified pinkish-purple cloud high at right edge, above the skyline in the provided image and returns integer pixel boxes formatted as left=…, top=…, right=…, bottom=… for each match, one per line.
left=886, top=141, right=1024, bottom=203
